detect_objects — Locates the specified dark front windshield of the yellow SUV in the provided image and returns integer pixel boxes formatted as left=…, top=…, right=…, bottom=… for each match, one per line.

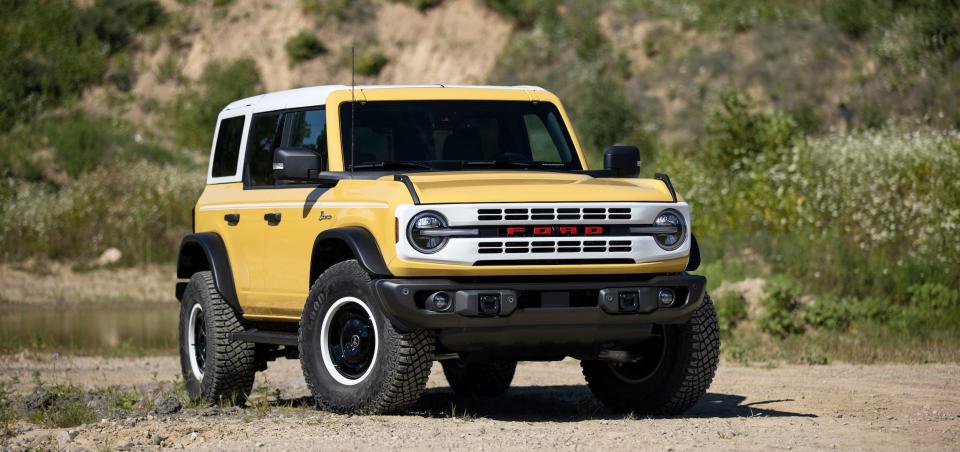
left=340, top=100, right=582, bottom=171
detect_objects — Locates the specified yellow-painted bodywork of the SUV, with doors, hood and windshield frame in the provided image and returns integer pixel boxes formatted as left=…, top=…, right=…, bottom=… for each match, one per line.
left=195, top=88, right=687, bottom=321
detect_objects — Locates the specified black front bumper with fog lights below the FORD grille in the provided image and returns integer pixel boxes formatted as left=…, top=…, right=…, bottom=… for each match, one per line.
left=374, top=274, right=706, bottom=356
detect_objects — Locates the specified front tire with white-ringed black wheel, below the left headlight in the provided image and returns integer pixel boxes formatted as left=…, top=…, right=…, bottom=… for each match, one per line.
left=300, top=260, right=433, bottom=413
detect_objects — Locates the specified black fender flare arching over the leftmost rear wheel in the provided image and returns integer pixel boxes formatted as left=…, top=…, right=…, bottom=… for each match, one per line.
left=177, top=232, right=243, bottom=314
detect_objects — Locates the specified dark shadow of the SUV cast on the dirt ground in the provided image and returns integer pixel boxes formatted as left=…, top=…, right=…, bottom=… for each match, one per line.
left=409, top=385, right=817, bottom=422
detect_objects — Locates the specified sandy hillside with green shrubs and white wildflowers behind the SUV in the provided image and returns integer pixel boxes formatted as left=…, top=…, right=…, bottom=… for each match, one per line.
left=0, top=0, right=960, bottom=361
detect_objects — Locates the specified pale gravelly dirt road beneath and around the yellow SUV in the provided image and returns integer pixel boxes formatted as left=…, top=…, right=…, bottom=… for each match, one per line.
left=0, top=357, right=960, bottom=450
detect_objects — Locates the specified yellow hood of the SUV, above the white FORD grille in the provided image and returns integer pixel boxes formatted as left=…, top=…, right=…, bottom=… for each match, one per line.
left=390, top=171, right=673, bottom=204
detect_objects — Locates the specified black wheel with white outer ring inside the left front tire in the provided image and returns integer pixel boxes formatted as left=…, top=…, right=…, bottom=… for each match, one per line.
left=327, top=304, right=376, bottom=379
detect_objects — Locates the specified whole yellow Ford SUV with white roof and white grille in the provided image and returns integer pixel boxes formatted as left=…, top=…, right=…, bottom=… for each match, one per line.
left=176, top=85, right=719, bottom=414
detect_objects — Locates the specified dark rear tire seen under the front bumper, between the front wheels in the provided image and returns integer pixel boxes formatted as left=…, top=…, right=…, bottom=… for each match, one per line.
left=440, top=359, right=517, bottom=397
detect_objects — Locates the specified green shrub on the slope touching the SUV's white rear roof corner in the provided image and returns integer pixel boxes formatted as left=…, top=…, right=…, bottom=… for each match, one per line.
left=173, top=58, right=263, bottom=149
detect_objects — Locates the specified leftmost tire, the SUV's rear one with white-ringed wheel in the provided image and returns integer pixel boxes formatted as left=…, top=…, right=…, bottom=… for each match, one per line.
left=180, top=271, right=257, bottom=405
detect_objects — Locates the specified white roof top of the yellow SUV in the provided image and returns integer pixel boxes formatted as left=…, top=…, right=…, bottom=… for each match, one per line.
left=223, top=85, right=543, bottom=112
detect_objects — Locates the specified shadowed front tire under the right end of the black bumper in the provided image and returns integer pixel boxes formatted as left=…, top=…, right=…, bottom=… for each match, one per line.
left=580, top=295, right=720, bottom=415
